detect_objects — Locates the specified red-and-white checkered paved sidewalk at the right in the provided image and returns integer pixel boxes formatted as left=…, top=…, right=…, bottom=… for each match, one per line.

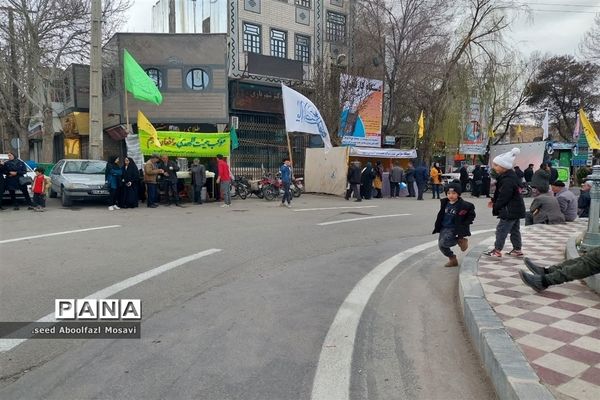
left=477, top=221, right=600, bottom=400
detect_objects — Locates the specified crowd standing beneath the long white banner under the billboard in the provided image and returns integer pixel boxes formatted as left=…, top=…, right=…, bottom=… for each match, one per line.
left=345, top=161, right=434, bottom=201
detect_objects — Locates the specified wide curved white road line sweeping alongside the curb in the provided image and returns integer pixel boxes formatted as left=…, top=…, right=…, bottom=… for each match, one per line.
left=310, top=229, right=495, bottom=400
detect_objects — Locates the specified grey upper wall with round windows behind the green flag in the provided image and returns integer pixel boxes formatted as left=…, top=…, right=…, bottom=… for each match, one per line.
left=104, top=33, right=229, bottom=128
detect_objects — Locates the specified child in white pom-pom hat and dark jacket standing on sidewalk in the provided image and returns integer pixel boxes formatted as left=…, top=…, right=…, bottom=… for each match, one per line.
left=483, top=147, right=525, bottom=257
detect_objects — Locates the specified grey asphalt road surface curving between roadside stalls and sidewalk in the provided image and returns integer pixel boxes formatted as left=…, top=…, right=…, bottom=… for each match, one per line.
left=0, top=195, right=496, bottom=400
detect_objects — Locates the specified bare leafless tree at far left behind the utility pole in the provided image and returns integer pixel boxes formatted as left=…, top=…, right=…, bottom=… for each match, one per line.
left=0, top=0, right=130, bottom=162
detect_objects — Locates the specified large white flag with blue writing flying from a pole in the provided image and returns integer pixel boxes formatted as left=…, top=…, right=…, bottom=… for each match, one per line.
left=281, top=83, right=331, bottom=150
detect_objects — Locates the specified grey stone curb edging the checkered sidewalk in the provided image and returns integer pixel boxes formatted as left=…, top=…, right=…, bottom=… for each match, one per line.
left=458, top=241, right=555, bottom=400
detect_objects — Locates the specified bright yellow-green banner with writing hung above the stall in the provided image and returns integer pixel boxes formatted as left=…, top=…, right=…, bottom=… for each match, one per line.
left=139, top=130, right=231, bottom=157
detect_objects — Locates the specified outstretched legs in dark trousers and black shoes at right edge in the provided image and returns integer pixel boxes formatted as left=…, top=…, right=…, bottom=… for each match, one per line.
left=519, top=247, right=600, bottom=292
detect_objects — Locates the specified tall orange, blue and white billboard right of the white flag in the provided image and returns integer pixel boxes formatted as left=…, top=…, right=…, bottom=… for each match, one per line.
left=338, top=74, right=383, bottom=147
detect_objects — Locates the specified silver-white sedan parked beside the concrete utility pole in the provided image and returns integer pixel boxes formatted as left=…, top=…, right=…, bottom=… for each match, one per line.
left=50, top=160, right=109, bottom=207
